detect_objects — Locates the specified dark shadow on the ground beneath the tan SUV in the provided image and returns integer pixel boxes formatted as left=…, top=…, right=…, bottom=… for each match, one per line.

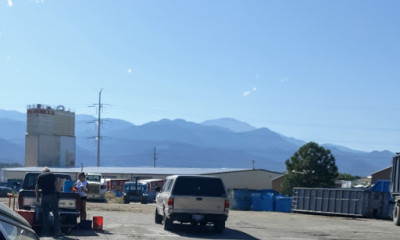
left=166, top=224, right=258, bottom=240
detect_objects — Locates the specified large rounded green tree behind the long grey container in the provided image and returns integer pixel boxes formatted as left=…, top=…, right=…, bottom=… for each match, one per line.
left=282, top=142, right=338, bottom=195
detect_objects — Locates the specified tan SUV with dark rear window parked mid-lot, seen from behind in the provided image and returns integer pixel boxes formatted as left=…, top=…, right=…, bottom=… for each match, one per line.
left=155, top=175, right=229, bottom=233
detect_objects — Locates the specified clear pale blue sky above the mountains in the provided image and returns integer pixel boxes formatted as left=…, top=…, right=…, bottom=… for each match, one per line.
left=0, top=0, right=400, bottom=152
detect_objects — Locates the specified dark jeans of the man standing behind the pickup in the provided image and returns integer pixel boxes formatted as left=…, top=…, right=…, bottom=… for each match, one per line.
left=42, top=193, right=61, bottom=234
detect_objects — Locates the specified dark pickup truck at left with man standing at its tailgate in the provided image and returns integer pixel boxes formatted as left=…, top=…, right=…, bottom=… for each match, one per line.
left=18, top=173, right=80, bottom=233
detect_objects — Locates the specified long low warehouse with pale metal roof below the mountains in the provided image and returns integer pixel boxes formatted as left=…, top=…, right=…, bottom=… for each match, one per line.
left=2, top=167, right=282, bottom=190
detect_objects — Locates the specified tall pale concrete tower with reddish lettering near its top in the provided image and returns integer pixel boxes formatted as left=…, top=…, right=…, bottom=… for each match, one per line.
left=25, top=104, right=76, bottom=167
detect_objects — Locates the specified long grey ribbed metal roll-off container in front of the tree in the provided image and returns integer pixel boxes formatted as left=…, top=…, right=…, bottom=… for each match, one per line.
left=292, top=188, right=388, bottom=218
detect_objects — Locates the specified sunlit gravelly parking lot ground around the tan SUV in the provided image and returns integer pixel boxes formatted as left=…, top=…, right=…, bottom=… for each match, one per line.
left=33, top=203, right=400, bottom=240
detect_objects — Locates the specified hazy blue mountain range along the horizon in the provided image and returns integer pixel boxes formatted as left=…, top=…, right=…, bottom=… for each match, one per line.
left=0, top=110, right=393, bottom=176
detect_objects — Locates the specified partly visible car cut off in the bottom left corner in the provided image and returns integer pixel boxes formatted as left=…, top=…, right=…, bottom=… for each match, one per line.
left=0, top=204, right=39, bottom=240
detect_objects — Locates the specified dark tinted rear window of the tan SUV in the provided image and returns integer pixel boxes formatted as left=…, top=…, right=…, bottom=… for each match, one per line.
left=172, top=177, right=225, bottom=197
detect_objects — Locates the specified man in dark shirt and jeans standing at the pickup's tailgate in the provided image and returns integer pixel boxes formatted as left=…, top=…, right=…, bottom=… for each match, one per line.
left=35, top=167, right=62, bottom=235
